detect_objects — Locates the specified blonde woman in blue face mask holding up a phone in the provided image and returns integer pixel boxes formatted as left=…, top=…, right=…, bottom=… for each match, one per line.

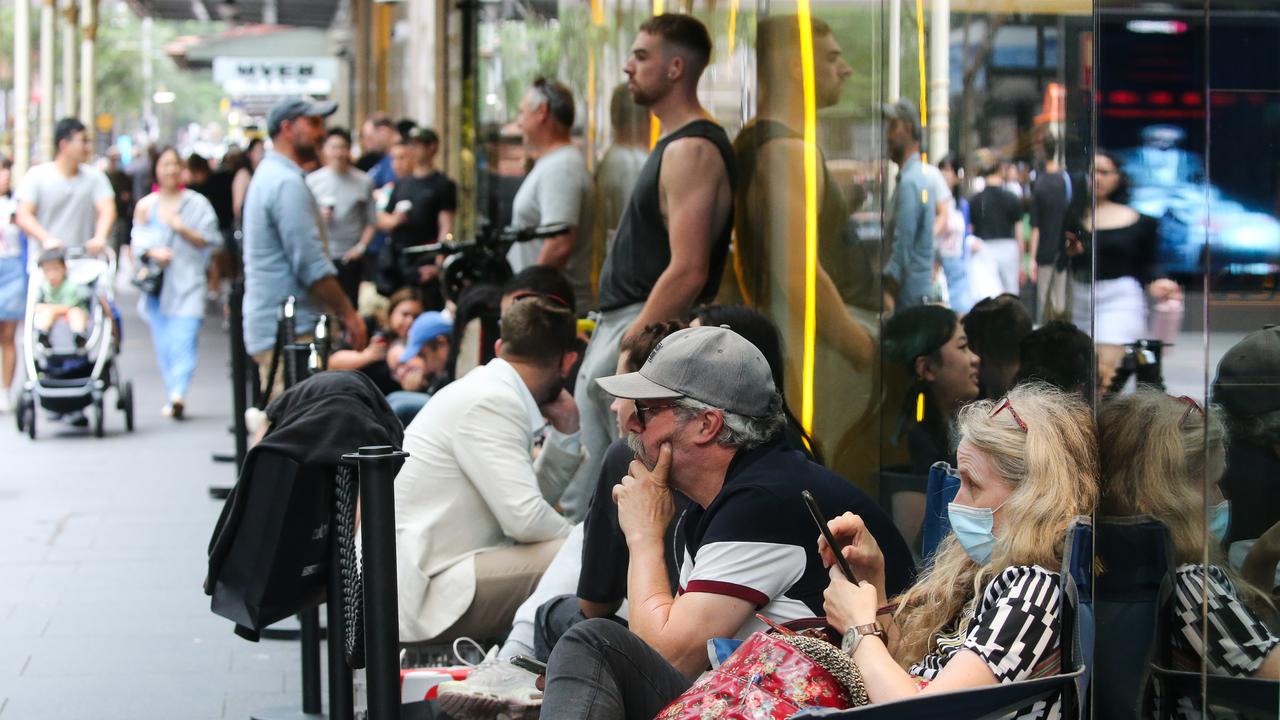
left=819, top=383, right=1098, bottom=720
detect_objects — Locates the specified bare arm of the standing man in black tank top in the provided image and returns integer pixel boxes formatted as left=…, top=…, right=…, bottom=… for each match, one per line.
left=626, top=137, right=733, bottom=336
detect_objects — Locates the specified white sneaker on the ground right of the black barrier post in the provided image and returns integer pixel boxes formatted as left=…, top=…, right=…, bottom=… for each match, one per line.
left=436, top=638, right=543, bottom=720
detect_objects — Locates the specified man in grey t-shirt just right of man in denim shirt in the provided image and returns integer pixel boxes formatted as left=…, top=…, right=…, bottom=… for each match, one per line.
left=307, top=128, right=378, bottom=305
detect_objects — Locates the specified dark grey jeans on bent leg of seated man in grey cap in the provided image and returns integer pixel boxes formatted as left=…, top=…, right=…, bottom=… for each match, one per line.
left=541, top=619, right=692, bottom=720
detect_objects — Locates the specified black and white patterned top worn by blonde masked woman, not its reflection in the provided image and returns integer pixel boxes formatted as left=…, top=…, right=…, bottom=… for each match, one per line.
left=909, top=565, right=1062, bottom=720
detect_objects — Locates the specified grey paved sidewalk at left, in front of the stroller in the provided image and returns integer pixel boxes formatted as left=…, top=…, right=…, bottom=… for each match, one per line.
left=0, top=283, right=300, bottom=720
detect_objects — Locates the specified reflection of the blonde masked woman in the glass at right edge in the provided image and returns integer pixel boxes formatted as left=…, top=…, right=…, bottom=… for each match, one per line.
left=1098, top=389, right=1280, bottom=681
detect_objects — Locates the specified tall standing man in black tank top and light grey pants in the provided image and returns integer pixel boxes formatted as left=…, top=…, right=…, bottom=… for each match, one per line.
left=561, top=14, right=735, bottom=521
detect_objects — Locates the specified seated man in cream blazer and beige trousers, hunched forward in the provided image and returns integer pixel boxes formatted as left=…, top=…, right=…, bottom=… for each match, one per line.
left=394, top=296, right=582, bottom=643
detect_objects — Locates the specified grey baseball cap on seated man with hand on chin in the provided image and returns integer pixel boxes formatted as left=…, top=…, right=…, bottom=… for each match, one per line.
left=595, top=327, right=777, bottom=418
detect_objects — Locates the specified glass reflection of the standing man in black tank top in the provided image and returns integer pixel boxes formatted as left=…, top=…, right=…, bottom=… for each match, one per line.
left=722, top=15, right=879, bottom=481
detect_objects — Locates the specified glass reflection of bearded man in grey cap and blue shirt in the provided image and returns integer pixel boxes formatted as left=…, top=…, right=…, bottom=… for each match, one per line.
left=881, top=99, right=938, bottom=311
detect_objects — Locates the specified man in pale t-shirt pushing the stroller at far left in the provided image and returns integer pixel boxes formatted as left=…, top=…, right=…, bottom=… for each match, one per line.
left=15, top=118, right=115, bottom=258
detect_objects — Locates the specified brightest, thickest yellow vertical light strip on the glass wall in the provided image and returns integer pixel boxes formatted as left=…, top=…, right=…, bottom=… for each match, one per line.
left=796, top=8, right=818, bottom=433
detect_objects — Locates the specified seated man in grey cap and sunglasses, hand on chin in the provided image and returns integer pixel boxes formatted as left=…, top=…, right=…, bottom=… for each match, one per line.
left=558, top=327, right=911, bottom=676
